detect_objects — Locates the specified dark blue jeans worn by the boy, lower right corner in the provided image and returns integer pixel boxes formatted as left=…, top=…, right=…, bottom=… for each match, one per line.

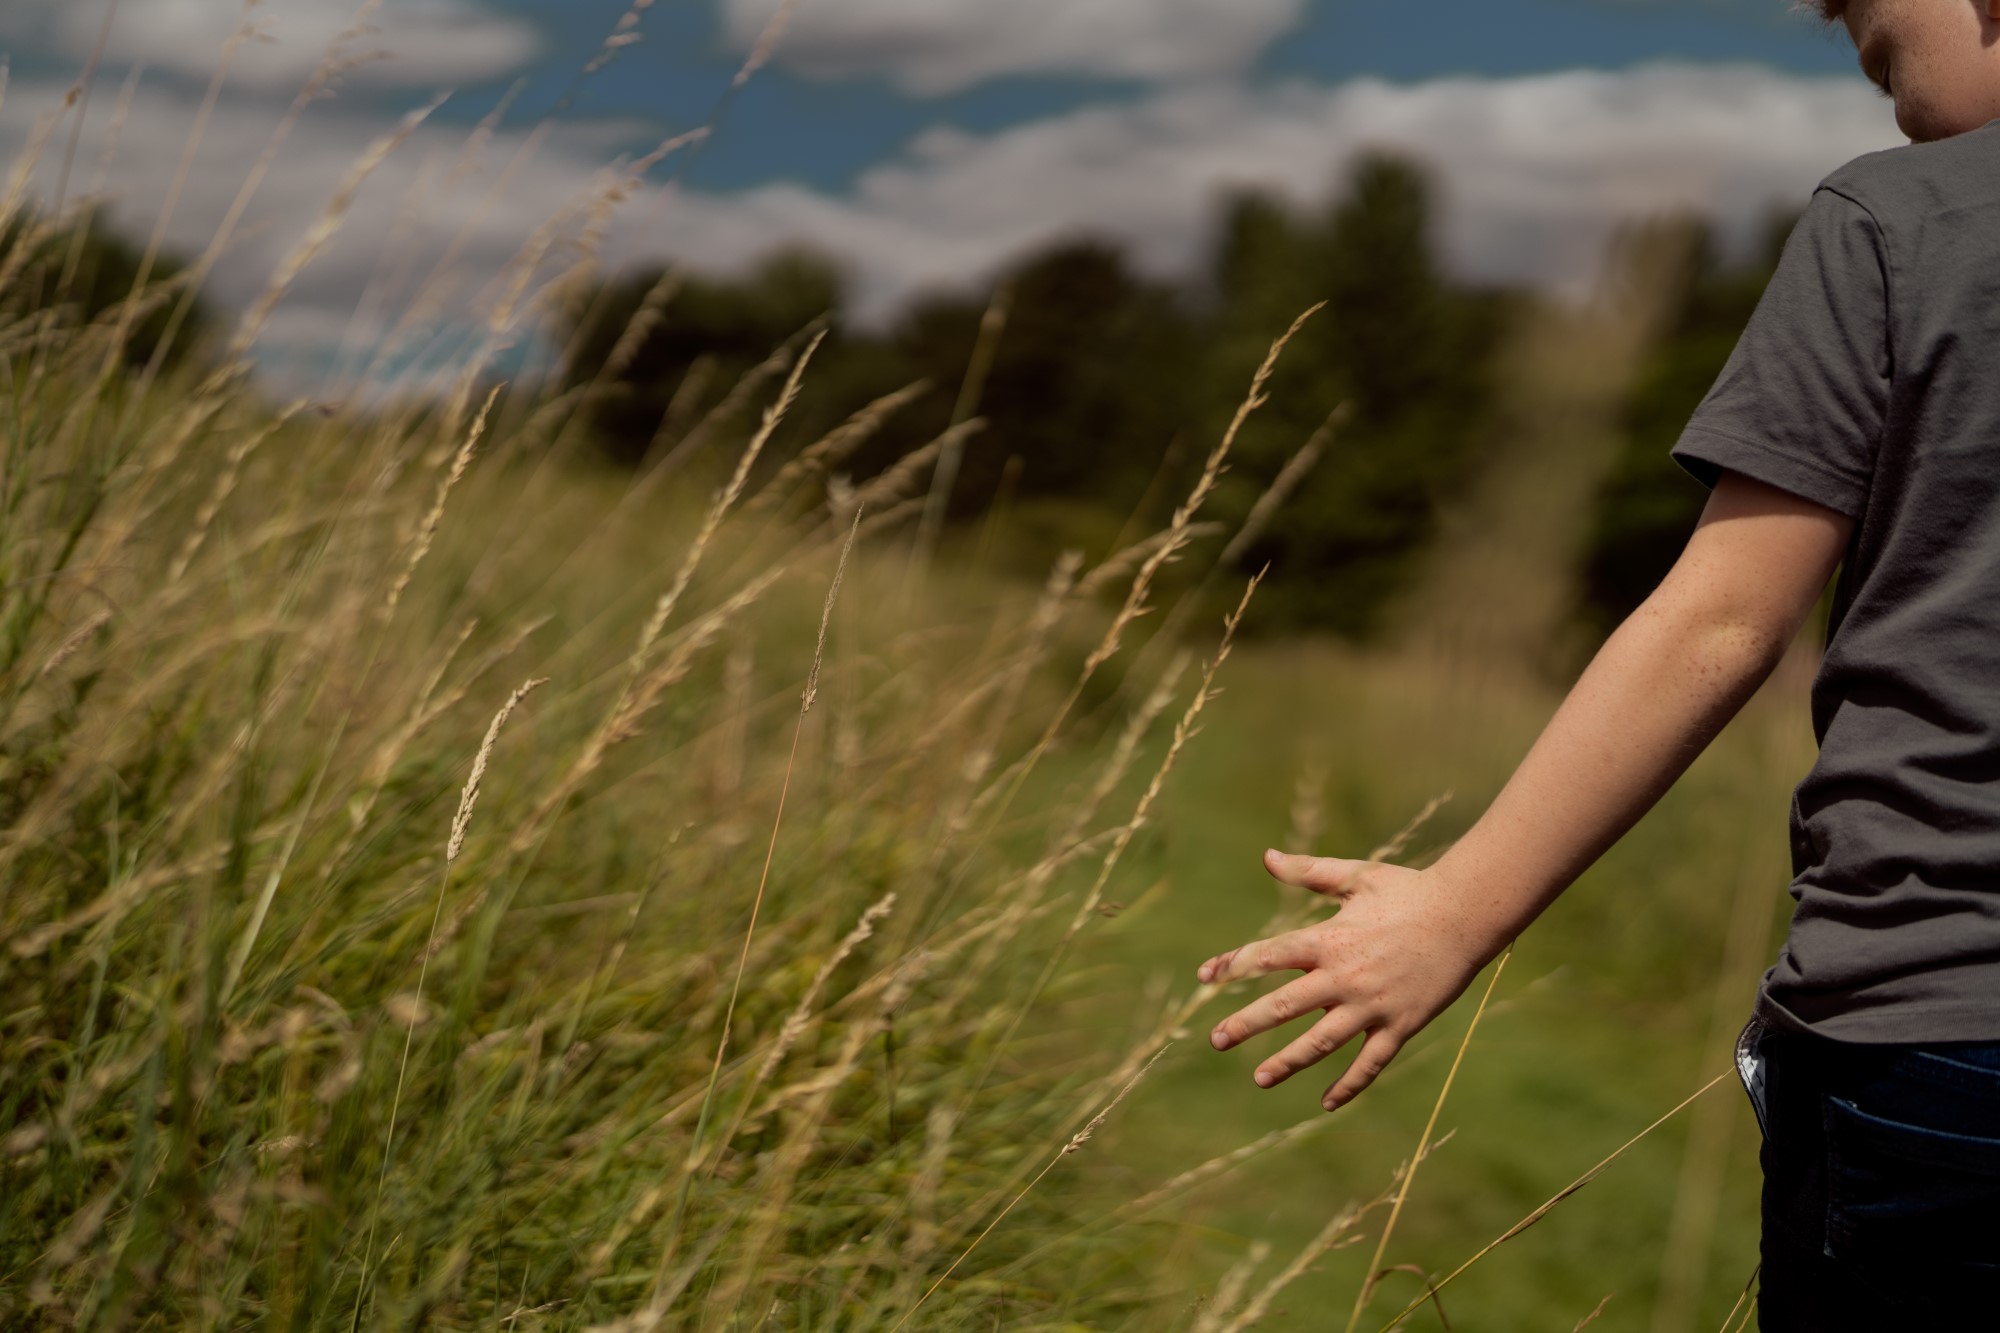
left=1756, top=1020, right=2000, bottom=1333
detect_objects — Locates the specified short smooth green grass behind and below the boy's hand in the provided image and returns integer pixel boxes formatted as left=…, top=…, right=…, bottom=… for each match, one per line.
left=1072, top=642, right=1810, bottom=1329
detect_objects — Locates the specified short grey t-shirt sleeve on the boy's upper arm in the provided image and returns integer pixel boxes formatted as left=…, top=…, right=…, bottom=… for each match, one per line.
left=1674, top=186, right=1892, bottom=518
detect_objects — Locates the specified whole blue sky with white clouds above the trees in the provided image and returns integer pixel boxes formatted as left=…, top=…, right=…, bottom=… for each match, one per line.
left=0, top=0, right=1902, bottom=390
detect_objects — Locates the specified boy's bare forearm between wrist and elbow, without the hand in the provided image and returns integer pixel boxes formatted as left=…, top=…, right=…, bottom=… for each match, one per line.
left=1432, top=580, right=1796, bottom=955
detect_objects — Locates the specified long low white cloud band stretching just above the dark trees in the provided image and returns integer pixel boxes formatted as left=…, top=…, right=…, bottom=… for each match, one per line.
left=0, top=66, right=1898, bottom=390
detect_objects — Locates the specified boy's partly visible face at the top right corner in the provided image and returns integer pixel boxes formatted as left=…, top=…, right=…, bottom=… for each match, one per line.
left=1840, top=0, right=2000, bottom=144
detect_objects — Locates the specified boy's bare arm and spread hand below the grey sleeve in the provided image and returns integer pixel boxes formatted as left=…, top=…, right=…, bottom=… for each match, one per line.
left=1200, top=472, right=1852, bottom=1111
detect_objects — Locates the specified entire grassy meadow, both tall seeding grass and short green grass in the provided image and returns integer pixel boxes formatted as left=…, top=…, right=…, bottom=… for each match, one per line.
left=0, top=41, right=1810, bottom=1333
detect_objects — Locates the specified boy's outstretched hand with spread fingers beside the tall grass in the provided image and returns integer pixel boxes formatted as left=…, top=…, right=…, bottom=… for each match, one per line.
left=1200, top=851, right=1506, bottom=1111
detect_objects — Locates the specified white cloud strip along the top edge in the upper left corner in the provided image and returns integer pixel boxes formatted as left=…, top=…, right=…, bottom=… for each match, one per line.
left=0, top=0, right=542, bottom=92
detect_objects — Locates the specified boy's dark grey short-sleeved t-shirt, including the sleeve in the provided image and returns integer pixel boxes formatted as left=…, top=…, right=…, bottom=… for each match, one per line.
left=1674, top=120, right=2000, bottom=1043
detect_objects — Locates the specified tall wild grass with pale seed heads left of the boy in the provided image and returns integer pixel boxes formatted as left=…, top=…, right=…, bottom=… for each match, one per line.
left=0, top=33, right=1816, bottom=1329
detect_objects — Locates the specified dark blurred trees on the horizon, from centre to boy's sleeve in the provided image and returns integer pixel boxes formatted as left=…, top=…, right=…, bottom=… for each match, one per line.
left=558, top=156, right=1784, bottom=636
